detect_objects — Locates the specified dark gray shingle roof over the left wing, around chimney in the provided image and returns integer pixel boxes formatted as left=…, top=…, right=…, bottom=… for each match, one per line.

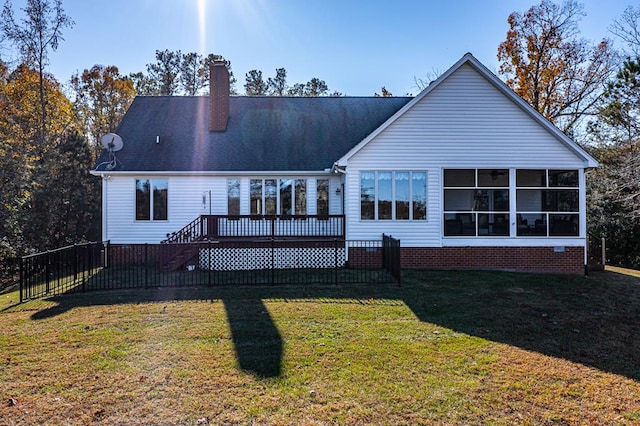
left=97, top=96, right=411, bottom=171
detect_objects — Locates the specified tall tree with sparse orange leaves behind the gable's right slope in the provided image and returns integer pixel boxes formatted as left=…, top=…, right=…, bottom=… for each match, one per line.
left=498, top=0, right=617, bottom=134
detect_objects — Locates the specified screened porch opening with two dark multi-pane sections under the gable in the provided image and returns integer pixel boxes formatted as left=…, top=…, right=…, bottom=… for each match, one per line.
left=443, top=168, right=582, bottom=238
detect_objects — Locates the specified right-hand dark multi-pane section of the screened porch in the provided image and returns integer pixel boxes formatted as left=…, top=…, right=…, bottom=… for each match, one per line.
left=516, top=169, right=580, bottom=237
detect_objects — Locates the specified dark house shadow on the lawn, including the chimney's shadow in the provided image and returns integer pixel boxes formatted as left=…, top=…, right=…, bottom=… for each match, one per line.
left=18, top=271, right=640, bottom=380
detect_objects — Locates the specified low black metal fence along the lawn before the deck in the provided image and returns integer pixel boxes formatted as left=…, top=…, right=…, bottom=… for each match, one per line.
left=20, top=236, right=400, bottom=302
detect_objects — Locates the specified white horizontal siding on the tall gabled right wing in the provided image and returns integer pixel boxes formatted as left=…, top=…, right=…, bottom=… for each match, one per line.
left=347, top=64, right=584, bottom=247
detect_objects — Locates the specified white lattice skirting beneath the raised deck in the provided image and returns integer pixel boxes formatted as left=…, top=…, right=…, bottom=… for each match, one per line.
left=200, top=247, right=346, bottom=271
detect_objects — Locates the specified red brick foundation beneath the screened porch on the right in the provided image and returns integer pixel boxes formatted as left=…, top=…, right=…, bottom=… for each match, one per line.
left=400, top=247, right=584, bottom=275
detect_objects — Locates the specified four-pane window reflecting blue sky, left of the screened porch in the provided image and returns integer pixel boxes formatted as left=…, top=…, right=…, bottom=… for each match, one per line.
left=360, top=171, right=427, bottom=220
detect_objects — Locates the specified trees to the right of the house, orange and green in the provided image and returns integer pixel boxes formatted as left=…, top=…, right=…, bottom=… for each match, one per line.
left=498, top=0, right=640, bottom=268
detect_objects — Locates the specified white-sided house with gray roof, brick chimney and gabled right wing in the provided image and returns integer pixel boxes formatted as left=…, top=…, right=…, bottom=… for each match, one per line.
left=92, top=54, right=598, bottom=274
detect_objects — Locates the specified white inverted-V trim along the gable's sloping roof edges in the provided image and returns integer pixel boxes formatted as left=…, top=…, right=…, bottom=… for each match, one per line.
left=334, top=53, right=599, bottom=171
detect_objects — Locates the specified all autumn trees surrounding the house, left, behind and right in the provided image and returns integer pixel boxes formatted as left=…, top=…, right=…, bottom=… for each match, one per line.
left=0, top=0, right=640, bottom=267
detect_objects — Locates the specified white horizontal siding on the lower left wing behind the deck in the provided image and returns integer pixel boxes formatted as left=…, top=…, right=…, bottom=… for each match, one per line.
left=103, top=174, right=341, bottom=244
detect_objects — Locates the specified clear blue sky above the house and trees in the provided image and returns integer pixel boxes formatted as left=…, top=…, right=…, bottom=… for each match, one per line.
left=32, top=0, right=633, bottom=96
